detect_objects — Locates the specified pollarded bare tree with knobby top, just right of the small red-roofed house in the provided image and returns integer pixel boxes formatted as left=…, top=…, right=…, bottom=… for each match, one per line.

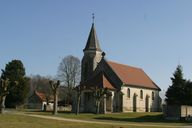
left=49, top=80, right=60, bottom=115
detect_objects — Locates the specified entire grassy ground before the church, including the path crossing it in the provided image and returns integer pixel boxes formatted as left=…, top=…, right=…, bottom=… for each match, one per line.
left=0, top=112, right=192, bottom=128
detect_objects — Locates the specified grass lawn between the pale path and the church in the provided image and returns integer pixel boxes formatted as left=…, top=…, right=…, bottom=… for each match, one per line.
left=23, top=112, right=192, bottom=127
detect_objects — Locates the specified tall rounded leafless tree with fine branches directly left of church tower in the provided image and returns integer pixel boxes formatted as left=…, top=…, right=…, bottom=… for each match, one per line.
left=57, top=55, right=80, bottom=103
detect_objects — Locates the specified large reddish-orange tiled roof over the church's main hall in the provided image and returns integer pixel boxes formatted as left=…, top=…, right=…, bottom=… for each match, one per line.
left=108, top=61, right=160, bottom=90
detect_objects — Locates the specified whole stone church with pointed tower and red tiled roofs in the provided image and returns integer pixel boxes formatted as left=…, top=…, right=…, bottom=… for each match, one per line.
left=72, top=23, right=161, bottom=113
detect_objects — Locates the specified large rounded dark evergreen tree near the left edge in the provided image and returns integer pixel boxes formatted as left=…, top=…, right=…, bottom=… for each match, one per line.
left=2, top=60, right=29, bottom=108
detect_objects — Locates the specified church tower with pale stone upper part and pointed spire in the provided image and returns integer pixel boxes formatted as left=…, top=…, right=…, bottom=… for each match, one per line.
left=81, top=23, right=102, bottom=82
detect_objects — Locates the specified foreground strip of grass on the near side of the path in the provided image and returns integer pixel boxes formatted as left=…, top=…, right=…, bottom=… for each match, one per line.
left=0, top=114, right=168, bottom=128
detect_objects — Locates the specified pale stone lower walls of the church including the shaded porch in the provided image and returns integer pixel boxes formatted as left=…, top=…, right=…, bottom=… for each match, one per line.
left=73, top=86, right=161, bottom=113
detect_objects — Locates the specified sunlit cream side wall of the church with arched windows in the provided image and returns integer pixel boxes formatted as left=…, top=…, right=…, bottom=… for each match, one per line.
left=122, top=86, right=161, bottom=112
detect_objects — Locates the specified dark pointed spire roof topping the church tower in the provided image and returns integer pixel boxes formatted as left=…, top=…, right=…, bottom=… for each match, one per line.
left=83, top=23, right=101, bottom=51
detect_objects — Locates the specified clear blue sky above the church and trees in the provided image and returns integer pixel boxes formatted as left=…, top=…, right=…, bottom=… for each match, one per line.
left=0, top=0, right=192, bottom=98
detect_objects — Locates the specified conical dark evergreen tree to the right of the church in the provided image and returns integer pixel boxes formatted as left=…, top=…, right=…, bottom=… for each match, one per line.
left=165, top=65, right=187, bottom=105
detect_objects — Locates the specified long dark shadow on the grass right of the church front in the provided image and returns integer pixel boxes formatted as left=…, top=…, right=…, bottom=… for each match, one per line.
left=94, top=114, right=192, bottom=125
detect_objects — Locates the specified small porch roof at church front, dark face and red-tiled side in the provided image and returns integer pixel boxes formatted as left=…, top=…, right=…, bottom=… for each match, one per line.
left=82, top=72, right=115, bottom=89
